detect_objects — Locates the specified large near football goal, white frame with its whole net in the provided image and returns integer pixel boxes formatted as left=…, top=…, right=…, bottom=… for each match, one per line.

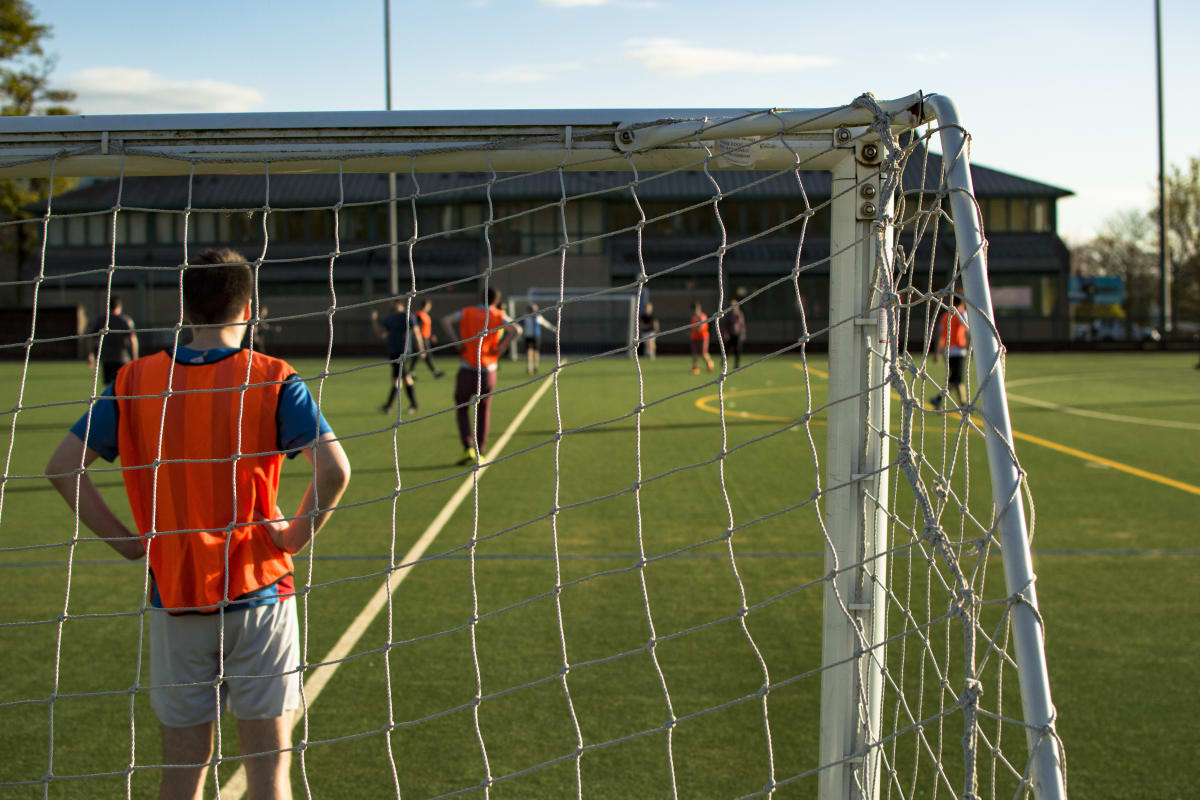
left=0, top=95, right=1066, bottom=800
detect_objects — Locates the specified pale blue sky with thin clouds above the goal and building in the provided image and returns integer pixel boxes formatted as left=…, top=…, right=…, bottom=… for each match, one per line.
left=31, top=0, right=1200, bottom=243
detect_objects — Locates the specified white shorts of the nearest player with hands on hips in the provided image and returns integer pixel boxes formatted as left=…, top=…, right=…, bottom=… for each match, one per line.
left=150, top=599, right=300, bottom=728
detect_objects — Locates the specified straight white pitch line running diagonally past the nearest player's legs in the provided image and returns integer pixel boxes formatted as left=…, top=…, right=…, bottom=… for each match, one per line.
left=221, top=377, right=553, bottom=800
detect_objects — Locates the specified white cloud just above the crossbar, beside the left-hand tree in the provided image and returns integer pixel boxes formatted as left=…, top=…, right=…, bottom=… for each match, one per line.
left=62, top=67, right=264, bottom=114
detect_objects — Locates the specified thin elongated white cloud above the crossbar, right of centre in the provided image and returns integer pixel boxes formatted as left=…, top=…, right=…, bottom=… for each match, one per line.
left=624, top=38, right=834, bottom=78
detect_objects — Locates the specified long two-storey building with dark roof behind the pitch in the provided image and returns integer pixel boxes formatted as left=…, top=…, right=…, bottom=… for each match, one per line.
left=16, top=154, right=1070, bottom=353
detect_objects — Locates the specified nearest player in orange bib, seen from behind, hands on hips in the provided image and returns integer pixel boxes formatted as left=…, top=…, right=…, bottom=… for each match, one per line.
left=46, top=249, right=350, bottom=798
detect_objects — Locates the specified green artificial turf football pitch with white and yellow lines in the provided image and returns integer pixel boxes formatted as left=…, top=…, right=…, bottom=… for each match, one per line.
left=0, top=353, right=1200, bottom=800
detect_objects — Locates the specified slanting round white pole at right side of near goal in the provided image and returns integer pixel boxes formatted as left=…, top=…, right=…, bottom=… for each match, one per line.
left=930, top=97, right=1067, bottom=800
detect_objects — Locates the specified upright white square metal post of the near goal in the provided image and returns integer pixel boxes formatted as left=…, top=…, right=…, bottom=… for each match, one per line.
left=817, top=144, right=888, bottom=800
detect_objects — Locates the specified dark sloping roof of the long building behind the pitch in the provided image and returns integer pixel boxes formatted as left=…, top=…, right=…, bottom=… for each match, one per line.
left=38, top=154, right=1072, bottom=212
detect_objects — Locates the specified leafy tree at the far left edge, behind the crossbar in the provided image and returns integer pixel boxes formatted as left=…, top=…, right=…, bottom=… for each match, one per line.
left=0, top=0, right=76, bottom=302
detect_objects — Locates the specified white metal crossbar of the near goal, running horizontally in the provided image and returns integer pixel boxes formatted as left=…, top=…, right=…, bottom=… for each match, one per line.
left=0, top=94, right=924, bottom=178
